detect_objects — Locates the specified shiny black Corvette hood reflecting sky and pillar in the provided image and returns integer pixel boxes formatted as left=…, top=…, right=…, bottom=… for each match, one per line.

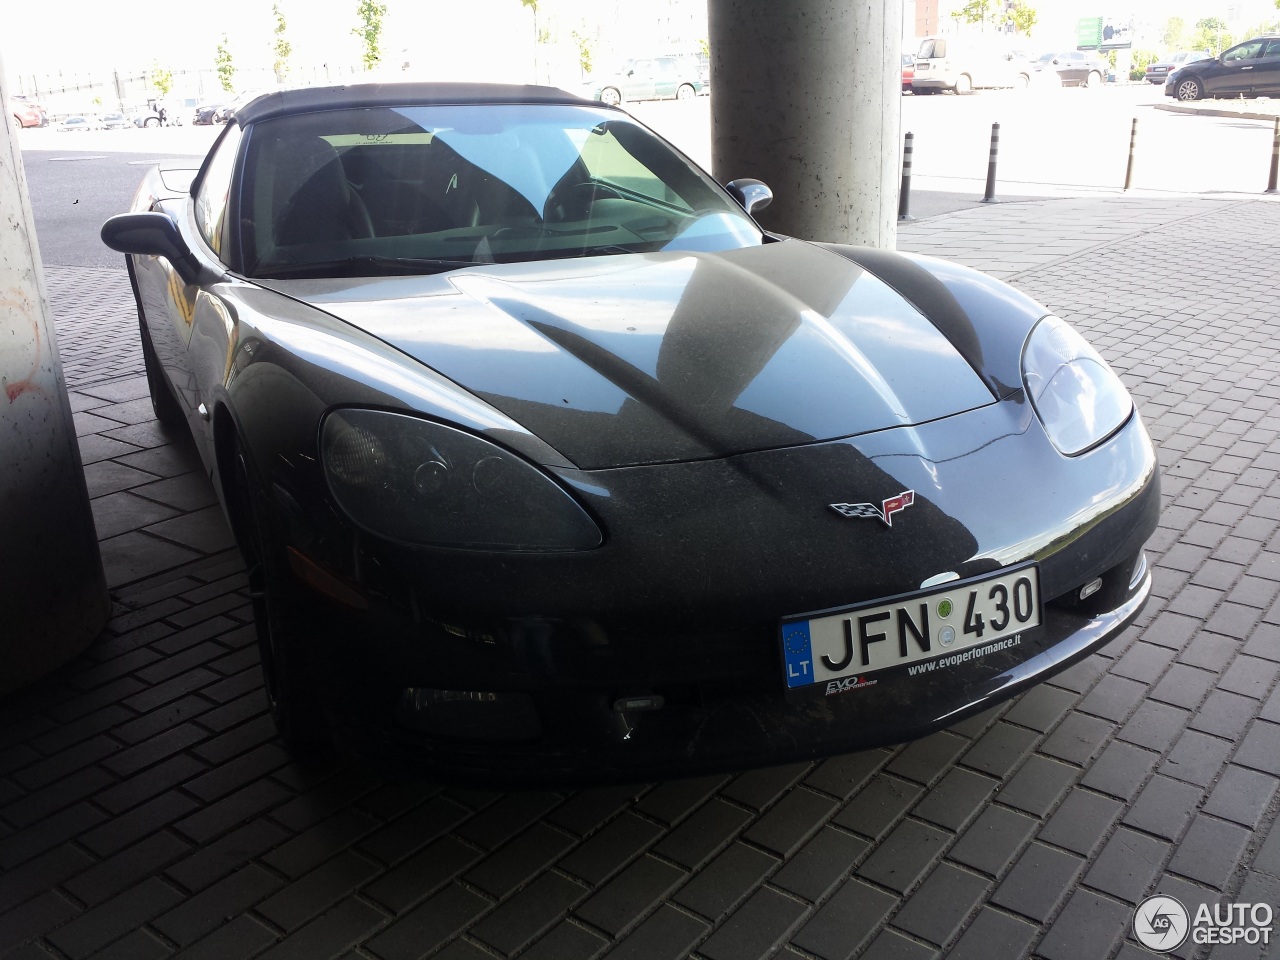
left=259, top=241, right=995, bottom=470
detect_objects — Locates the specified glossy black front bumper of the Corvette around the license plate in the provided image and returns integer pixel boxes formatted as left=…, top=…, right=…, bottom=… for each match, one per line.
left=270, top=401, right=1160, bottom=782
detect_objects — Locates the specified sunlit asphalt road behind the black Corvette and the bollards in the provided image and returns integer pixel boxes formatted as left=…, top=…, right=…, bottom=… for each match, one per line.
left=19, top=84, right=1272, bottom=266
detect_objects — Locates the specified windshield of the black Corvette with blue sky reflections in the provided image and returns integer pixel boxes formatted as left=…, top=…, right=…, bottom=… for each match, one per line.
left=239, top=104, right=763, bottom=278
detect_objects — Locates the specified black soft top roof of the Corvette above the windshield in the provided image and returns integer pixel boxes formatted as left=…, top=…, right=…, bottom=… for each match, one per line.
left=236, top=83, right=600, bottom=125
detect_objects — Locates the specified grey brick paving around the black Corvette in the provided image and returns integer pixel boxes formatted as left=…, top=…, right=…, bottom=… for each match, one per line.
left=0, top=196, right=1280, bottom=960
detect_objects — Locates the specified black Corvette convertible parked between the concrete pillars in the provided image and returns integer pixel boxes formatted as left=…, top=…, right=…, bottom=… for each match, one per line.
left=102, top=84, right=1160, bottom=782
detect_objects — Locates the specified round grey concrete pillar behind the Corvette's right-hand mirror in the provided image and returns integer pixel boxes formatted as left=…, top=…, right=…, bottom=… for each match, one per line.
left=708, top=0, right=902, bottom=248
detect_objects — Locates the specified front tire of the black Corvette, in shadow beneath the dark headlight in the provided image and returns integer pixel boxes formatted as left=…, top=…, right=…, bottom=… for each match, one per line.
left=229, top=447, right=332, bottom=755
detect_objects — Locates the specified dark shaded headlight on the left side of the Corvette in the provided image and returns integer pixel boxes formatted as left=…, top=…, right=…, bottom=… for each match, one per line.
left=320, top=410, right=602, bottom=552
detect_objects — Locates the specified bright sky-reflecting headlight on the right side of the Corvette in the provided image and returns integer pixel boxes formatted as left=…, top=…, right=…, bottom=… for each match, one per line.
left=1023, top=316, right=1133, bottom=457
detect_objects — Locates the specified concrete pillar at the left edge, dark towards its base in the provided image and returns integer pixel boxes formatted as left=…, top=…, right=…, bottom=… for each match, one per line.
left=0, top=64, right=110, bottom=692
